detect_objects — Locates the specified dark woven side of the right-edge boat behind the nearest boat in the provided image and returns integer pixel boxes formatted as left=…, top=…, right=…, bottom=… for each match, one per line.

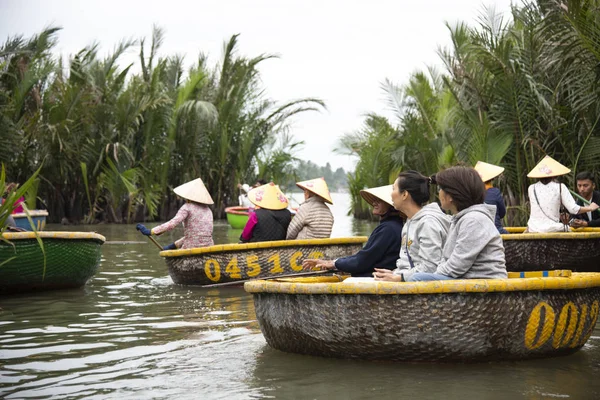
left=504, top=239, right=600, bottom=272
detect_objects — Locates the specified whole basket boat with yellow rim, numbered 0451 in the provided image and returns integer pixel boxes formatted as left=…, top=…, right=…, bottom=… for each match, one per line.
left=160, top=236, right=367, bottom=285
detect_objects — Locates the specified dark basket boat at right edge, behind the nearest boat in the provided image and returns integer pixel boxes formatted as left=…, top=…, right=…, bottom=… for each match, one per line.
left=502, top=227, right=600, bottom=272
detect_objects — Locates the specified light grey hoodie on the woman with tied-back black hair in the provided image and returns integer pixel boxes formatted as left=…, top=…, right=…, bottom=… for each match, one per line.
left=394, top=203, right=450, bottom=280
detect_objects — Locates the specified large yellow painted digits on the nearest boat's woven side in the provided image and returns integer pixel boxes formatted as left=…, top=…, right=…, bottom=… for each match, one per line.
left=525, top=300, right=600, bottom=350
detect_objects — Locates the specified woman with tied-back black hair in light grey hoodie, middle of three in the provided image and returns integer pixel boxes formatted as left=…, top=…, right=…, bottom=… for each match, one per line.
left=373, top=171, right=450, bottom=282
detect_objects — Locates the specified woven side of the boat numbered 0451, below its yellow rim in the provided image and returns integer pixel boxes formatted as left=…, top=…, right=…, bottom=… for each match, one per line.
left=165, top=243, right=362, bottom=285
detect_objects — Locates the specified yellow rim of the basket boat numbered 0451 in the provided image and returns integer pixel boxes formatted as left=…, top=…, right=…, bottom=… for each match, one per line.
left=159, top=236, right=368, bottom=257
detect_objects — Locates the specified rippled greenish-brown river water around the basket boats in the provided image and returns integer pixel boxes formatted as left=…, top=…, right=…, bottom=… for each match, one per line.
left=0, top=194, right=600, bottom=400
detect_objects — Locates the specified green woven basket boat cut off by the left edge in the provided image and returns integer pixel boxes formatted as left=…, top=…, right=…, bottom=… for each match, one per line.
left=0, top=232, right=105, bottom=294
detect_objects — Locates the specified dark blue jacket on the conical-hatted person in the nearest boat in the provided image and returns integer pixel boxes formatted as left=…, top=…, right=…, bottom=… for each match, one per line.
left=335, top=216, right=403, bottom=277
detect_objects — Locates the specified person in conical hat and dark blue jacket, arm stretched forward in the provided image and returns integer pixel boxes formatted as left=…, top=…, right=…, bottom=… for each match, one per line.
left=302, top=185, right=403, bottom=277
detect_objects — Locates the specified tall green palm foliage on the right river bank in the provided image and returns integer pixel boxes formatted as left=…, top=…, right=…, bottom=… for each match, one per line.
left=339, top=0, right=600, bottom=225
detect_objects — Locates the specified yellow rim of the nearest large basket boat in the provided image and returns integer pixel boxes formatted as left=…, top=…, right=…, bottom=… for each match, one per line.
left=244, top=272, right=600, bottom=295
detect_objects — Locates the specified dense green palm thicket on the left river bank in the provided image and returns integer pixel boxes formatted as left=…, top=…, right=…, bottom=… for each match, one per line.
left=0, top=28, right=324, bottom=222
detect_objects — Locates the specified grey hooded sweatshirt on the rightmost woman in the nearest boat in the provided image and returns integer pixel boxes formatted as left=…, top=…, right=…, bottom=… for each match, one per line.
left=435, top=204, right=507, bottom=279
